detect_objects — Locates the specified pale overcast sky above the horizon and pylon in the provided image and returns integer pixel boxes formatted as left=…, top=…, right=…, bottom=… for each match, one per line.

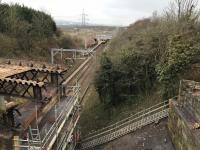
left=2, top=0, right=170, bottom=25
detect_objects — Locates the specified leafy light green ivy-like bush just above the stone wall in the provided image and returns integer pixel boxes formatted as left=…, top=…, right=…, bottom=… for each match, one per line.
left=156, top=35, right=200, bottom=98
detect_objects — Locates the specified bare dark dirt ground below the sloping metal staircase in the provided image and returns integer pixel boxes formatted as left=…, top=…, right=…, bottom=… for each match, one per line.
left=94, top=119, right=175, bottom=150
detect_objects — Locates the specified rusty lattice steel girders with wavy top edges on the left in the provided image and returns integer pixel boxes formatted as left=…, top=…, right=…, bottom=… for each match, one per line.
left=0, top=63, right=66, bottom=101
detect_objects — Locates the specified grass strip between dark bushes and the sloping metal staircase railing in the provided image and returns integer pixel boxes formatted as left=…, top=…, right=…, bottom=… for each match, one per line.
left=80, top=87, right=162, bottom=136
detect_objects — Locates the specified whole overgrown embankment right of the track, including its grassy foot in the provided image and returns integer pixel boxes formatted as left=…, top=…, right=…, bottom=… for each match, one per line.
left=81, top=0, right=200, bottom=135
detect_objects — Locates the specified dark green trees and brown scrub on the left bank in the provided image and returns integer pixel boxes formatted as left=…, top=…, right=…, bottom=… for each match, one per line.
left=0, top=4, right=82, bottom=59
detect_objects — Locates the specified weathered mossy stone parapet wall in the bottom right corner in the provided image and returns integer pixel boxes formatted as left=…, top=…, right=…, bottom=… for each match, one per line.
left=168, top=80, right=200, bottom=150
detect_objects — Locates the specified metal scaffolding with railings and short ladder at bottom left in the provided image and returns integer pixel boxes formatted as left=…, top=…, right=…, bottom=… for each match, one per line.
left=14, top=84, right=80, bottom=150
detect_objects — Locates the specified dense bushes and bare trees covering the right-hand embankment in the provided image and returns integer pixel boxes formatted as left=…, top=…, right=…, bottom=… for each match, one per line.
left=95, top=0, right=200, bottom=105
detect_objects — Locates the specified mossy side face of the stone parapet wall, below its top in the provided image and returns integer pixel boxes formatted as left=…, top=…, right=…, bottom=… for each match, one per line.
left=168, top=101, right=200, bottom=150
